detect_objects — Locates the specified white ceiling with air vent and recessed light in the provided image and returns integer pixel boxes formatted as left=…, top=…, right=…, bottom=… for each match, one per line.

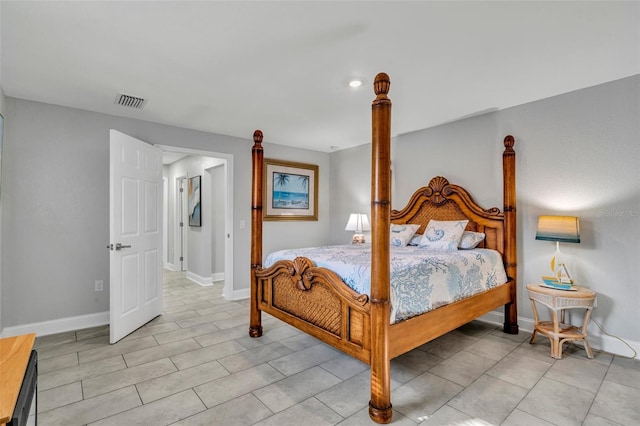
left=0, top=1, right=640, bottom=152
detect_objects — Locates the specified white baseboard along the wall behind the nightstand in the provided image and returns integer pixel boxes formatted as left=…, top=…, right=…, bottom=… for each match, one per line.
left=478, top=311, right=640, bottom=358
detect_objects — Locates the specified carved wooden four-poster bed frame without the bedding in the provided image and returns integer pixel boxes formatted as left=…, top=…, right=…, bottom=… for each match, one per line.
left=249, top=73, right=518, bottom=423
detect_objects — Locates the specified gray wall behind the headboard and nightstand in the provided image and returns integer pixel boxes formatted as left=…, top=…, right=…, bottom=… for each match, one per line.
left=331, top=76, right=640, bottom=354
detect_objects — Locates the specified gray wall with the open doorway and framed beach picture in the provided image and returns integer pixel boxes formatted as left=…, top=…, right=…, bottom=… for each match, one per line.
left=0, top=98, right=330, bottom=328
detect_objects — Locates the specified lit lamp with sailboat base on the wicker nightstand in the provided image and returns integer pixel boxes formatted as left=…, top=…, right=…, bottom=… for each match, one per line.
left=536, top=216, right=580, bottom=283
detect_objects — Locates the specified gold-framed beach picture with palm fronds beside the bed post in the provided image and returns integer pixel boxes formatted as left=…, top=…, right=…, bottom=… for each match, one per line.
left=264, top=159, right=318, bottom=220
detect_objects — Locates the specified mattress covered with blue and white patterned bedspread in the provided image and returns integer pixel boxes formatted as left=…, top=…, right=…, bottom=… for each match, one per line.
left=264, top=244, right=507, bottom=324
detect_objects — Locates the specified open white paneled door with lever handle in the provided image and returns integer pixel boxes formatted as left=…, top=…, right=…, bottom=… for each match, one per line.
left=109, top=130, right=162, bottom=343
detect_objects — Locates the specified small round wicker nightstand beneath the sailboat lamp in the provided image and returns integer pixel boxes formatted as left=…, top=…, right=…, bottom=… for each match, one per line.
left=527, top=284, right=596, bottom=359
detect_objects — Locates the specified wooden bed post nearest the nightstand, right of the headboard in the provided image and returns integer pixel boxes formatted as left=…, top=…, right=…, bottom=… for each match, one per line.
left=502, top=135, right=518, bottom=334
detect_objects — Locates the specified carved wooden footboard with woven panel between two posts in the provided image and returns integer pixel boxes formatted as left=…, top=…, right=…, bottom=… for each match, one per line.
left=254, top=257, right=371, bottom=364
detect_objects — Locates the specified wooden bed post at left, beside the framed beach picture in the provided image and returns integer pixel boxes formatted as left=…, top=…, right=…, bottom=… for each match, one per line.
left=249, top=130, right=264, bottom=337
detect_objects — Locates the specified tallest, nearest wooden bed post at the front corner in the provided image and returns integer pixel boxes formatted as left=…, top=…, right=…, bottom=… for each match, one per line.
left=369, top=73, right=392, bottom=423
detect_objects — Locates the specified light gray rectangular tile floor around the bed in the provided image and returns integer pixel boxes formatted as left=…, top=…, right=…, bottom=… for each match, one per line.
left=36, top=272, right=640, bottom=426
